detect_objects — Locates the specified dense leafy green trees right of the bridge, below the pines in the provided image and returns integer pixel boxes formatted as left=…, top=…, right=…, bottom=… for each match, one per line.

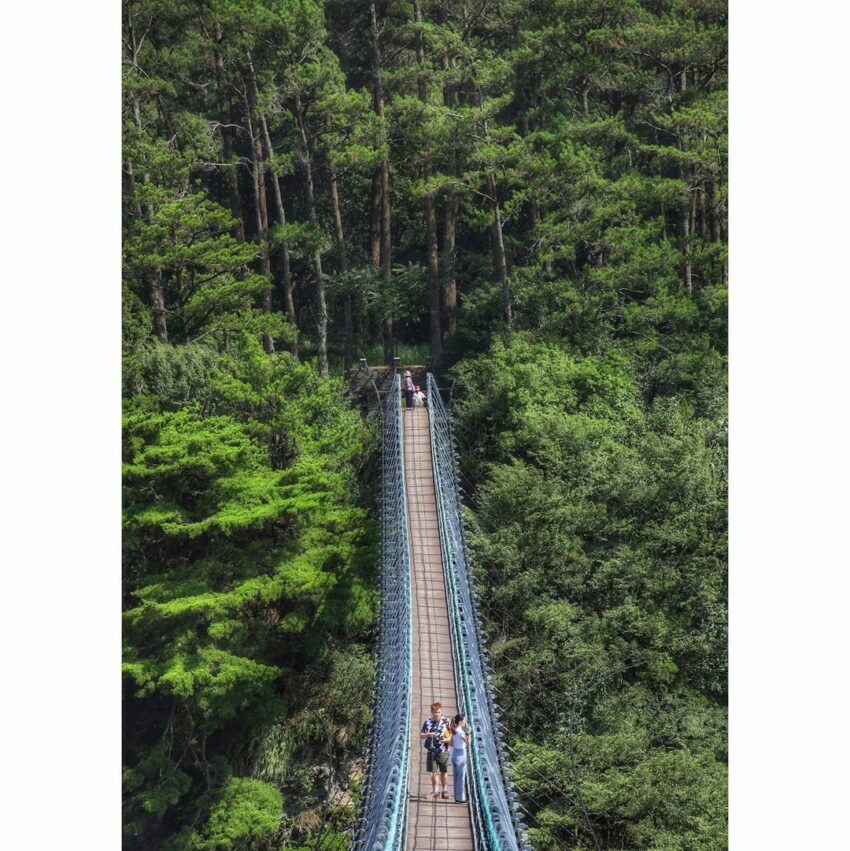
left=456, top=342, right=726, bottom=849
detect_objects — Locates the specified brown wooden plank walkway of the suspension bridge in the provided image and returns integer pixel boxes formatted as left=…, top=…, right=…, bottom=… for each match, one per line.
left=402, top=408, right=474, bottom=851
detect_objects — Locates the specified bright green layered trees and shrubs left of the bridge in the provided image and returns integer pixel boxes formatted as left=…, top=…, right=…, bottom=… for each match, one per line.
left=124, top=335, right=375, bottom=851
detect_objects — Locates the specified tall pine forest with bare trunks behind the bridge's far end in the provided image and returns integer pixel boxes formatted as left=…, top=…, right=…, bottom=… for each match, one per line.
left=125, top=0, right=726, bottom=376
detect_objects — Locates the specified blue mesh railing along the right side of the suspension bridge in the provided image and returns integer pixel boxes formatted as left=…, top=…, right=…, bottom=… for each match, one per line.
left=428, top=373, right=531, bottom=851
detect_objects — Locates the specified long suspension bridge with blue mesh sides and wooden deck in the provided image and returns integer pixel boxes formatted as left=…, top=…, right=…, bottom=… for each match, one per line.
left=346, top=370, right=531, bottom=851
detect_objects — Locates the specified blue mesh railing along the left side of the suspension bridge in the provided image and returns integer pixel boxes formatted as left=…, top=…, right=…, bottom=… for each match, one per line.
left=354, top=375, right=413, bottom=851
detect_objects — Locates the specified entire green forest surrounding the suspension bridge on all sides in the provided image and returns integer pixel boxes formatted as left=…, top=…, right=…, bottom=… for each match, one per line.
left=123, top=0, right=727, bottom=851
